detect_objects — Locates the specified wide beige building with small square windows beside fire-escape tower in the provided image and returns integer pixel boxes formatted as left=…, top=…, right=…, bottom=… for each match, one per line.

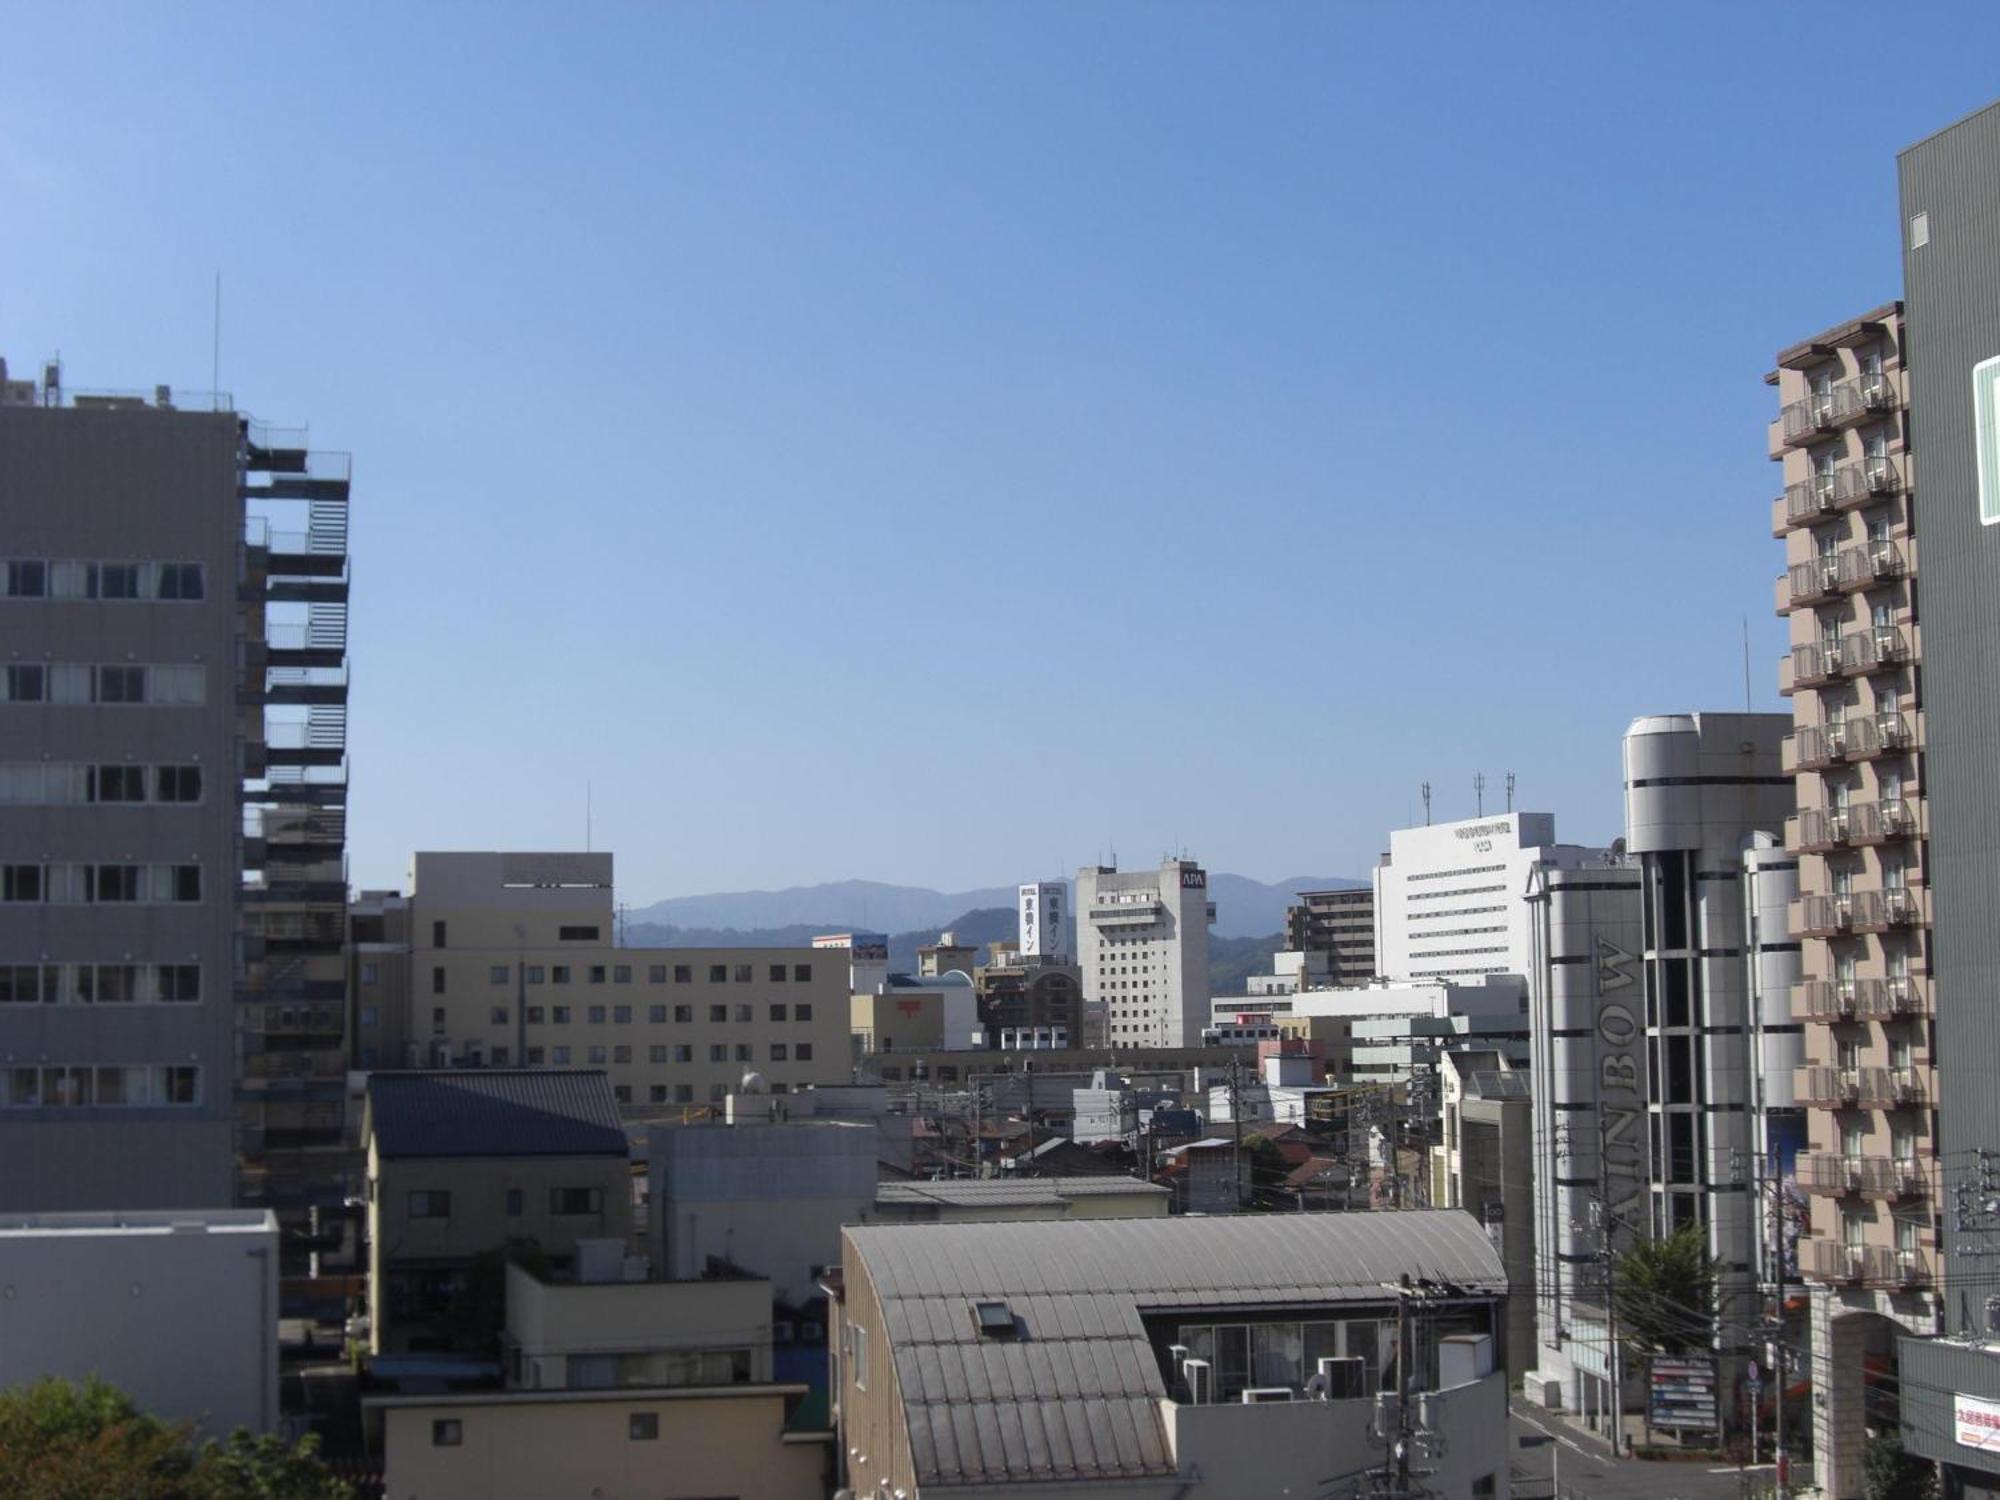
left=352, top=852, right=850, bottom=1108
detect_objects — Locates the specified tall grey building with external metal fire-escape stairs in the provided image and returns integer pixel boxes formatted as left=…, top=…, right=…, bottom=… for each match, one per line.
left=0, top=366, right=346, bottom=1212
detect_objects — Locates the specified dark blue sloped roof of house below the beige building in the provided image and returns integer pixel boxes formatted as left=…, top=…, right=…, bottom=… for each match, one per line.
left=368, top=1068, right=630, bottom=1156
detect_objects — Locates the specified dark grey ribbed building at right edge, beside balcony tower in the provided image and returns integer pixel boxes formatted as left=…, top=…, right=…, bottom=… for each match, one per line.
left=1896, top=106, right=2000, bottom=1494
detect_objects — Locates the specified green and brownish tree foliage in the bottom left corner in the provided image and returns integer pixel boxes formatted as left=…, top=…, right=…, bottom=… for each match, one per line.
left=0, top=1376, right=352, bottom=1500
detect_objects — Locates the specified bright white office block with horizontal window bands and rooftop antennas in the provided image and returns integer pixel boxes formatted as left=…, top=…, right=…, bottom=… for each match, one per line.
left=1374, top=812, right=1612, bottom=984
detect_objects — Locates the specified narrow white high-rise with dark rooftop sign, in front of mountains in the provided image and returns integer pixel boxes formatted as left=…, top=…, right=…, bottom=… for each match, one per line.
left=1076, top=860, right=1216, bottom=1046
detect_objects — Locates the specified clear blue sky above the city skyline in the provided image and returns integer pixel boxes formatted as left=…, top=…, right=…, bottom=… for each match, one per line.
left=0, top=0, right=2000, bottom=902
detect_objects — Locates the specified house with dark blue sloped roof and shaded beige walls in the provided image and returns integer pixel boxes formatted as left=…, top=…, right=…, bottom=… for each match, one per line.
left=362, top=1068, right=632, bottom=1354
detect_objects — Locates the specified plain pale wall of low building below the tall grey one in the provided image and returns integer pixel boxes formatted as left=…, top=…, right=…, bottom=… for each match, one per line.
left=0, top=1208, right=278, bottom=1438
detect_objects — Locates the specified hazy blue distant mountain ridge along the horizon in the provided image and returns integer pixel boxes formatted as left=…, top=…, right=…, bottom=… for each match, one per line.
left=626, top=872, right=1368, bottom=938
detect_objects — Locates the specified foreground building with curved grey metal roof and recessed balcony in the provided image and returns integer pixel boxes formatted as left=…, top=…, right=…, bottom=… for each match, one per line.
left=832, top=1210, right=1512, bottom=1500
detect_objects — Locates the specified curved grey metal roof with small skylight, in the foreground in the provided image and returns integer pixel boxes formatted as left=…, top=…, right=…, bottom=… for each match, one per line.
left=846, top=1208, right=1506, bottom=1484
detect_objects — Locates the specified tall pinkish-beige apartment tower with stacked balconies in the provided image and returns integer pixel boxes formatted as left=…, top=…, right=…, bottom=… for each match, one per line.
left=1766, top=302, right=1938, bottom=1496
